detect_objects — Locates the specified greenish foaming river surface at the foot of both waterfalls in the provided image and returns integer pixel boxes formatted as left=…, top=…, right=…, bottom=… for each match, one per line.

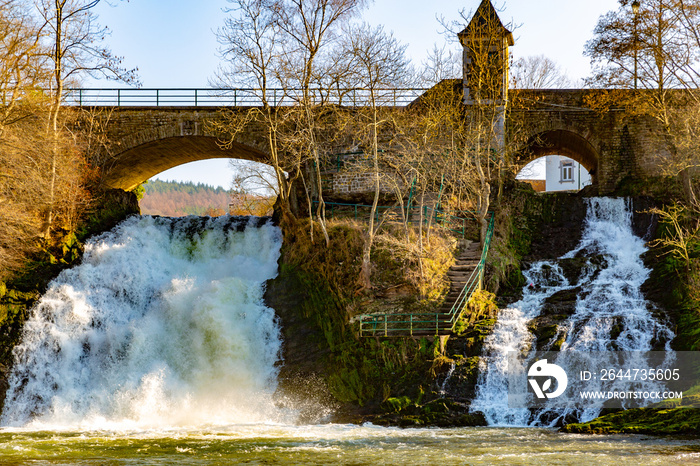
left=0, top=424, right=700, bottom=466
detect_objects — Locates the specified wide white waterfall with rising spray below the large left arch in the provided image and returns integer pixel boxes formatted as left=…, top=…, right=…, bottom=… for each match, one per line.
left=0, top=216, right=284, bottom=429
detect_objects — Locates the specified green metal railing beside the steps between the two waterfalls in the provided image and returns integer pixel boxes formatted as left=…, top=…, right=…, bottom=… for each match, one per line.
left=360, top=213, right=494, bottom=337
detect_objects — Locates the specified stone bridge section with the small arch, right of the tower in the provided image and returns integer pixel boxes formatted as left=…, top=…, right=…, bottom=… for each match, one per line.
left=506, top=89, right=669, bottom=195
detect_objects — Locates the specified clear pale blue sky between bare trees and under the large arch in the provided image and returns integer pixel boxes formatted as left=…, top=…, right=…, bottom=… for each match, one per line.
left=91, top=0, right=618, bottom=188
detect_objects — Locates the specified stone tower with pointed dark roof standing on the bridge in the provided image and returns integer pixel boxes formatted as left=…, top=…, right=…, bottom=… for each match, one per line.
left=458, top=0, right=514, bottom=107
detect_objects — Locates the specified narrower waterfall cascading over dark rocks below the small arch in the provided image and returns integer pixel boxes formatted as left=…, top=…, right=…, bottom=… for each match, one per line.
left=472, top=198, right=673, bottom=426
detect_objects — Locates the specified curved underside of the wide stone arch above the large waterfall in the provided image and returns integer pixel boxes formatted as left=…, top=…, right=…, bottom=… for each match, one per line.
left=103, top=135, right=269, bottom=191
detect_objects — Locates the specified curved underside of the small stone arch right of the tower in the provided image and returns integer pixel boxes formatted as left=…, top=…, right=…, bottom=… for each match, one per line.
left=518, top=129, right=600, bottom=183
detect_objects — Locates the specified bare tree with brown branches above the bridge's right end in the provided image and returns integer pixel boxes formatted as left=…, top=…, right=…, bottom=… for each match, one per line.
left=584, top=0, right=700, bottom=128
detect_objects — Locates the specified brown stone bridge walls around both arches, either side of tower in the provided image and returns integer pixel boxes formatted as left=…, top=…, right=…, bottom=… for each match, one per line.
left=87, top=90, right=668, bottom=194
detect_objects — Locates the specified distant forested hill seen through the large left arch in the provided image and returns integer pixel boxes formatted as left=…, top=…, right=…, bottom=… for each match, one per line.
left=139, top=180, right=230, bottom=217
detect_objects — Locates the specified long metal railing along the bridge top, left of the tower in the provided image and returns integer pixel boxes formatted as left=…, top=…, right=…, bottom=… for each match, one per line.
left=63, top=88, right=426, bottom=107
